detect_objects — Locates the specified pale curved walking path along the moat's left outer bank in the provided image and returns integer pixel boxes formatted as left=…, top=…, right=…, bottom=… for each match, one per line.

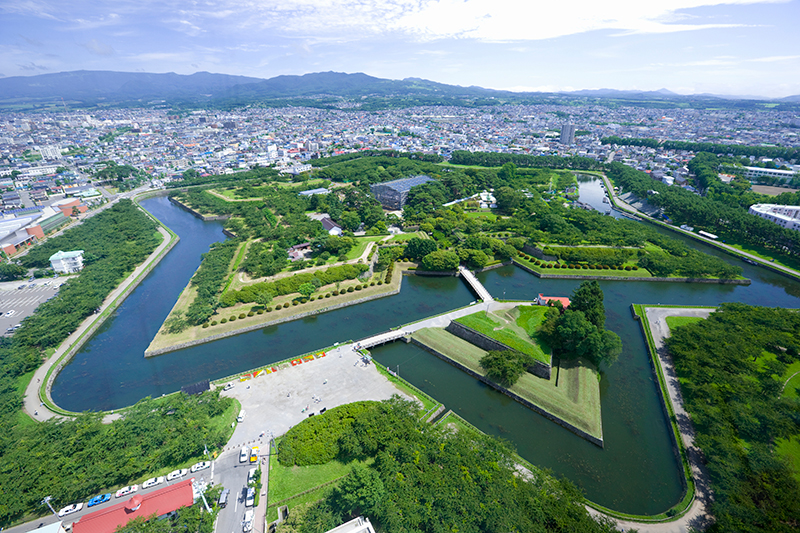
left=22, top=226, right=177, bottom=423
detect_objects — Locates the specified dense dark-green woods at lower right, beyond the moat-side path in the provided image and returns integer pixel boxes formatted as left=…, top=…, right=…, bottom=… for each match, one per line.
left=666, top=303, right=800, bottom=532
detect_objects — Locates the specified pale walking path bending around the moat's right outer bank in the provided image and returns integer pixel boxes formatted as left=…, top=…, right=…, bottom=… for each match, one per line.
left=589, top=307, right=714, bottom=533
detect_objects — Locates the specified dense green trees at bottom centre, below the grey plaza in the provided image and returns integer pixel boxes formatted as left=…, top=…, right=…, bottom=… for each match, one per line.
left=278, top=397, right=616, bottom=533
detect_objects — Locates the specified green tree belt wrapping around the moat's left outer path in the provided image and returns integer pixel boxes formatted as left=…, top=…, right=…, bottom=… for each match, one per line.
left=0, top=200, right=230, bottom=525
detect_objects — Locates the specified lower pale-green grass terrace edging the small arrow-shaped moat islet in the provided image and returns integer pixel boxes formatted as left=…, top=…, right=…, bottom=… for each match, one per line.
left=413, top=328, right=603, bottom=438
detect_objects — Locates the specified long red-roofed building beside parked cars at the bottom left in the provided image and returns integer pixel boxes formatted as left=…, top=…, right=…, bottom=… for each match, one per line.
left=72, top=479, right=194, bottom=533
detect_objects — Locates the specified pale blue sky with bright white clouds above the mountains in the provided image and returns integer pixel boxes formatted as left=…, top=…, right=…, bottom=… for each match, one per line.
left=0, top=0, right=800, bottom=97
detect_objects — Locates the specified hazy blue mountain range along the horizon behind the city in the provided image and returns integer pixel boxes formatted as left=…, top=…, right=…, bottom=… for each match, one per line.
left=0, top=70, right=800, bottom=110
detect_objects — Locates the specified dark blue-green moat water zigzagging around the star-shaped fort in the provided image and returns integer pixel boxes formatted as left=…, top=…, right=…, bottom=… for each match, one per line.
left=52, top=189, right=800, bottom=514
